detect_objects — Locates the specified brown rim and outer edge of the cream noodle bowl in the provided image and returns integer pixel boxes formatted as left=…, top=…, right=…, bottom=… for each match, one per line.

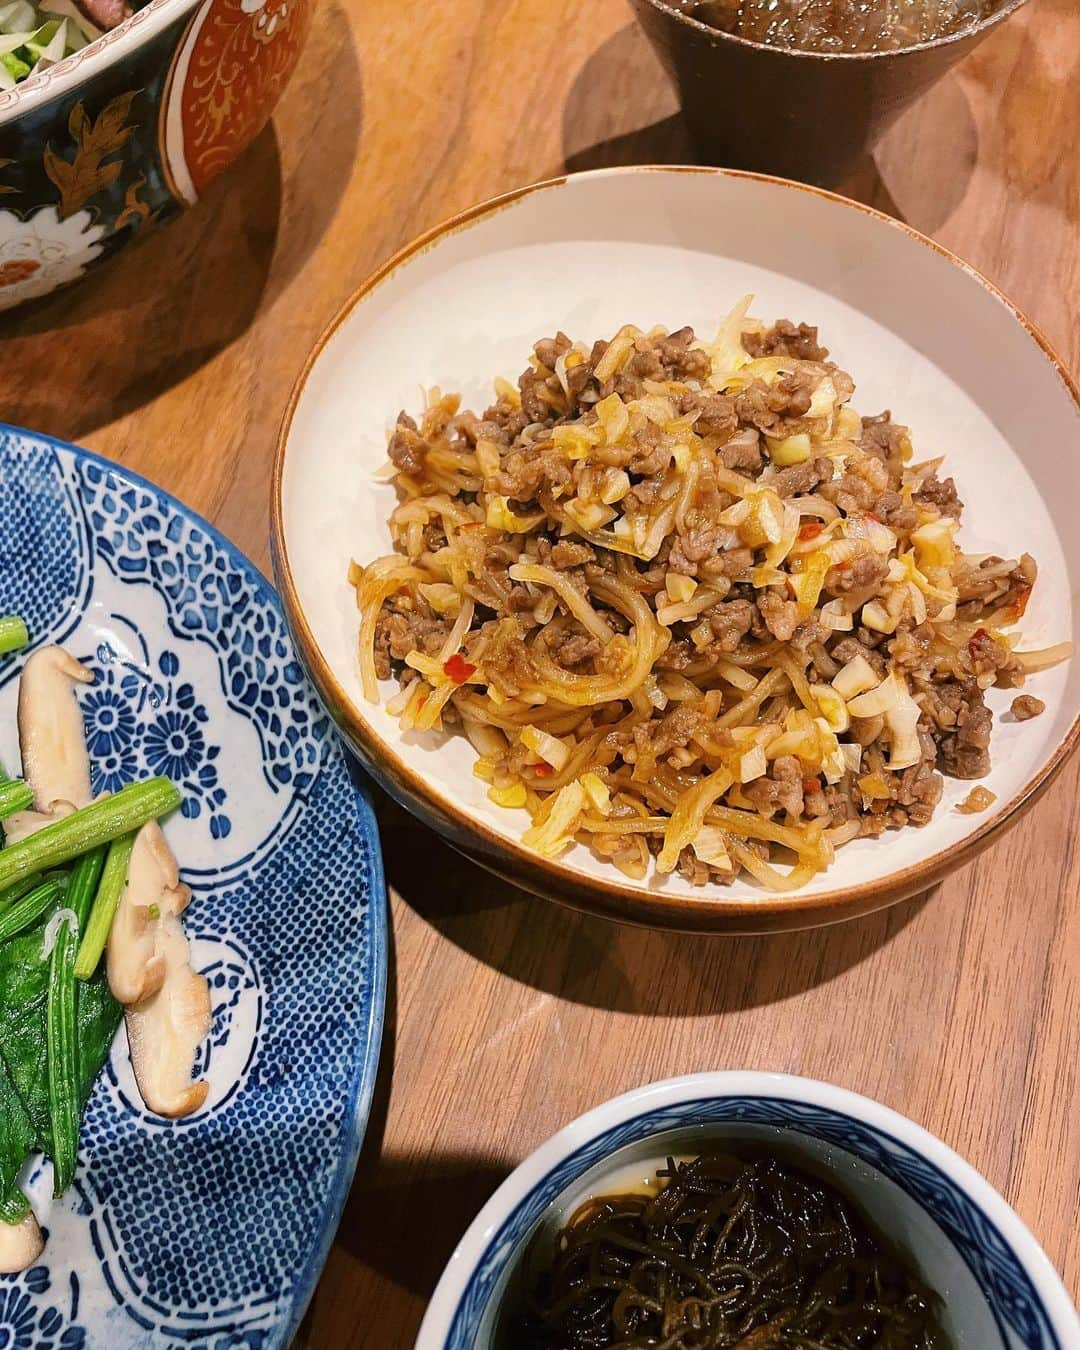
left=270, top=165, right=1080, bottom=933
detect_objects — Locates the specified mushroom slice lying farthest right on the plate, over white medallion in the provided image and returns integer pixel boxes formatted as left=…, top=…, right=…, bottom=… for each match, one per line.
left=127, top=914, right=211, bottom=1116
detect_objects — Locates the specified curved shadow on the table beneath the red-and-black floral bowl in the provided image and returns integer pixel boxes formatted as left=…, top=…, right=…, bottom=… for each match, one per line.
left=0, top=4, right=362, bottom=440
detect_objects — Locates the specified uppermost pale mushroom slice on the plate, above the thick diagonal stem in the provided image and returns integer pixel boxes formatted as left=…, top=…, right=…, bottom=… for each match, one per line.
left=19, top=647, right=93, bottom=815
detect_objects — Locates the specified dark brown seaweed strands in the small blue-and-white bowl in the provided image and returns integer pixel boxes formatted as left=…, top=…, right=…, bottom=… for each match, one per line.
left=506, top=1154, right=948, bottom=1350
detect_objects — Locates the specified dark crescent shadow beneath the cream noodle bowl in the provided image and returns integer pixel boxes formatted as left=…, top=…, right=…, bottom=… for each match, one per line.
left=378, top=798, right=934, bottom=1017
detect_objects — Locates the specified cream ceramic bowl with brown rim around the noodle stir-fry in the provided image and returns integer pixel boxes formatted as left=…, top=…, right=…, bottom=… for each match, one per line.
left=273, top=169, right=1080, bottom=932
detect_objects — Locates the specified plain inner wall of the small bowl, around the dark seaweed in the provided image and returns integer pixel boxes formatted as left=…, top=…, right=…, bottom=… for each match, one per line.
left=475, top=1125, right=1006, bottom=1350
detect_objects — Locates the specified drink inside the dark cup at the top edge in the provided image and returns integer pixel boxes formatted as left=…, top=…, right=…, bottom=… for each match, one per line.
left=674, top=0, right=1002, bottom=51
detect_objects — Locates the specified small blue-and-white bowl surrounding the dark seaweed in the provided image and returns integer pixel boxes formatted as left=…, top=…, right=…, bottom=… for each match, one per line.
left=416, top=1072, right=1080, bottom=1350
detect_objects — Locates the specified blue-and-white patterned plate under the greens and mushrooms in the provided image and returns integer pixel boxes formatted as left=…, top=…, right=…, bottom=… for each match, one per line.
left=0, top=425, right=386, bottom=1350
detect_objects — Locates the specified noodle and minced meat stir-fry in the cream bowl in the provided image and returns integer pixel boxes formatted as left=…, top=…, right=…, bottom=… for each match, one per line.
left=350, top=297, right=1069, bottom=891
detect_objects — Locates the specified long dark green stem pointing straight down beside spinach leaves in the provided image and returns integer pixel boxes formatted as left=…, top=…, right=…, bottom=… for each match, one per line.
left=45, top=915, right=78, bottom=1196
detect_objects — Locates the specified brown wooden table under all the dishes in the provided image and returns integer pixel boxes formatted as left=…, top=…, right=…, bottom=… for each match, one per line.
left=0, top=0, right=1080, bottom=1350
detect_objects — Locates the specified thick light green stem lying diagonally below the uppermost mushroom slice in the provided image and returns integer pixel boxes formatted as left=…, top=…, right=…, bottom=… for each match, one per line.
left=0, top=778, right=180, bottom=891
